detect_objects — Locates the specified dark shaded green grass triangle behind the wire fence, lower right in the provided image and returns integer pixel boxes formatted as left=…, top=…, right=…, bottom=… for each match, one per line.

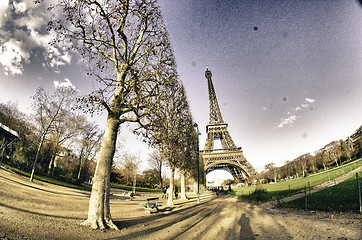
left=282, top=173, right=362, bottom=212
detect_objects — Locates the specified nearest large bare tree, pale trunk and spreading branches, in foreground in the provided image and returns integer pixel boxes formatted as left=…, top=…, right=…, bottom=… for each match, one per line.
left=53, top=0, right=179, bottom=229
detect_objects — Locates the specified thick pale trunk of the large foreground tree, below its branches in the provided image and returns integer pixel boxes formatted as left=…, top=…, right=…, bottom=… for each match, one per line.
left=82, top=116, right=119, bottom=229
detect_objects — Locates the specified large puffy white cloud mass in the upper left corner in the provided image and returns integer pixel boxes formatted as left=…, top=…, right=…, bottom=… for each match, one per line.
left=0, top=0, right=71, bottom=75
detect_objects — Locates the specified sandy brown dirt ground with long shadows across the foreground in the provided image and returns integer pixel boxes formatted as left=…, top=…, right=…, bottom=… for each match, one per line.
left=0, top=169, right=362, bottom=240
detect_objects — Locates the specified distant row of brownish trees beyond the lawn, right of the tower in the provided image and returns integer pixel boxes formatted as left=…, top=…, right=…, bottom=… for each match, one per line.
left=261, top=126, right=362, bottom=182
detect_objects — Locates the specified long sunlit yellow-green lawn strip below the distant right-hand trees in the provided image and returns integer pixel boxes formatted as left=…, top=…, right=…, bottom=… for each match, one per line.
left=233, top=159, right=362, bottom=202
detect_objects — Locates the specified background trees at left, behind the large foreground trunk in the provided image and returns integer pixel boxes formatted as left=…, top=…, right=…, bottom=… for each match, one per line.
left=0, top=96, right=196, bottom=188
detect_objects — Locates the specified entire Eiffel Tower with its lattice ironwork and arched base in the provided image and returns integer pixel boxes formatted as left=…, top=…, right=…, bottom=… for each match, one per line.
left=200, top=67, right=257, bottom=180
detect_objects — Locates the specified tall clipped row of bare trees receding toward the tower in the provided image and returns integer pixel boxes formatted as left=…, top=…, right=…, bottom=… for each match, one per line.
left=46, top=0, right=197, bottom=229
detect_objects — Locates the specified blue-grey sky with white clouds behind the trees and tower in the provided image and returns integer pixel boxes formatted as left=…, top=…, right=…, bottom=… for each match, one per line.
left=0, top=0, right=362, bottom=179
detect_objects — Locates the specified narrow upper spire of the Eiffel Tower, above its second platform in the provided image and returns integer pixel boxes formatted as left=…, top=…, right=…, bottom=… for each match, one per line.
left=205, top=66, right=224, bottom=124
